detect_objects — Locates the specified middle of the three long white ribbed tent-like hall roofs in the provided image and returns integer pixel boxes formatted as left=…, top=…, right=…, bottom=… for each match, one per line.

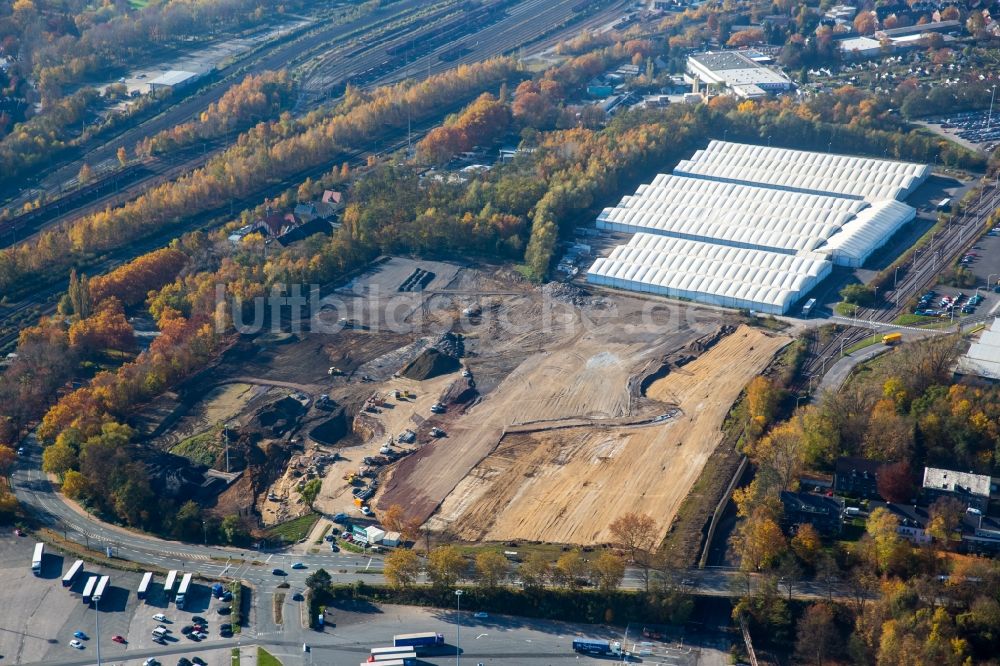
left=597, top=174, right=866, bottom=254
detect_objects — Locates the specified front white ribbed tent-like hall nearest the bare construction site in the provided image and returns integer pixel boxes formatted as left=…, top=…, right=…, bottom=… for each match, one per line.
left=587, top=233, right=832, bottom=314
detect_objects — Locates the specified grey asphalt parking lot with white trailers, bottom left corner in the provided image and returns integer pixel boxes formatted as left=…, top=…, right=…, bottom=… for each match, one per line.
left=0, top=530, right=240, bottom=664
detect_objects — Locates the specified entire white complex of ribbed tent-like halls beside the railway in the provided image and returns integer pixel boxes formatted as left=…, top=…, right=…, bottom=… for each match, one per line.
left=587, top=141, right=930, bottom=314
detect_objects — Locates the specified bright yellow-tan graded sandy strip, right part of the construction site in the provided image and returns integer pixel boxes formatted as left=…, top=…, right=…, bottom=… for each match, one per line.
left=430, top=327, right=789, bottom=544
